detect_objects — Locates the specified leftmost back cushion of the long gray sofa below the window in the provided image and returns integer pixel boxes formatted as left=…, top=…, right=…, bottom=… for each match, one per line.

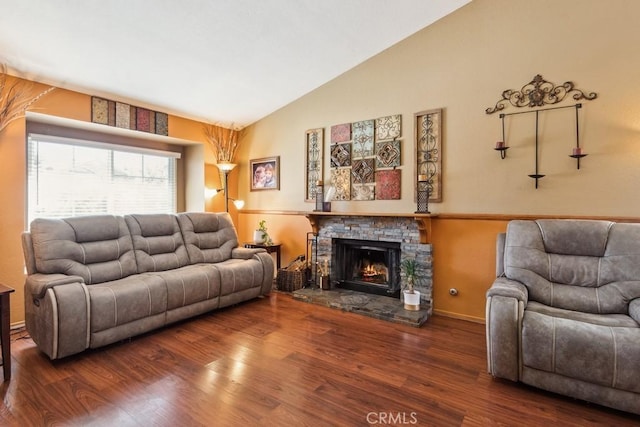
left=30, top=215, right=136, bottom=285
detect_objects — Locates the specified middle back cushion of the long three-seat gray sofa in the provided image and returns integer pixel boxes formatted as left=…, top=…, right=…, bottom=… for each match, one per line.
left=124, top=214, right=189, bottom=273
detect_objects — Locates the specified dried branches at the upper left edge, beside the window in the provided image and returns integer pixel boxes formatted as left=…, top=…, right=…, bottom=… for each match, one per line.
left=0, top=64, right=55, bottom=132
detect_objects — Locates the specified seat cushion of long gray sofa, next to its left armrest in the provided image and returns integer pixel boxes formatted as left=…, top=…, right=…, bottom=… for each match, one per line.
left=87, top=274, right=167, bottom=335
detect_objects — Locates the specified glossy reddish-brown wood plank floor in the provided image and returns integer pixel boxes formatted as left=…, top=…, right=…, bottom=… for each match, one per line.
left=0, top=293, right=640, bottom=426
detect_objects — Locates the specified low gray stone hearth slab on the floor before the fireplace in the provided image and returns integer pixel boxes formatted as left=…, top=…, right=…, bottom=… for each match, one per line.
left=292, top=288, right=431, bottom=327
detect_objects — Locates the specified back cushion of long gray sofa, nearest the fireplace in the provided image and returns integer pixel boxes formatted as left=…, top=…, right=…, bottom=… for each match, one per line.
left=178, top=212, right=238, bottom=264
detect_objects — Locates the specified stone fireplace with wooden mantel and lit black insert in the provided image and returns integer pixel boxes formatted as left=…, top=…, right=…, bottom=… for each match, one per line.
left=307, top=212, right=433, bottom=314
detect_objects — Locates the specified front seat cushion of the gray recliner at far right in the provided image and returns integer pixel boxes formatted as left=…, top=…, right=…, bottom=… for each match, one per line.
left=522, top=309, right=640, bottom=393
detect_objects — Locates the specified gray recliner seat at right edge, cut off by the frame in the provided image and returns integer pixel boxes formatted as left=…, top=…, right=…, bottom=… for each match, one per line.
left=486, top=220, right=640, bottom=414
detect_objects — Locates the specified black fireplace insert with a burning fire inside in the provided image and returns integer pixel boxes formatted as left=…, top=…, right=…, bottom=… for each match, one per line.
left=331, top=239, right=400, bottom=298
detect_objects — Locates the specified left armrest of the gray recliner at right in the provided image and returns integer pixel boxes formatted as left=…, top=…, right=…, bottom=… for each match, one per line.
left=485, top=277, right=529, bottom=381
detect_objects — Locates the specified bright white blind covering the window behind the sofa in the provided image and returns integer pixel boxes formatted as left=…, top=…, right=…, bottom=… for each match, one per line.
left=27, top=134, right=180, bottom=223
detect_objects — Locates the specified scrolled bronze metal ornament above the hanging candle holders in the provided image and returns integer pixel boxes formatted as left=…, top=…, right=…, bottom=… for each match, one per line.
left=485, top=74, right=598, bottom=114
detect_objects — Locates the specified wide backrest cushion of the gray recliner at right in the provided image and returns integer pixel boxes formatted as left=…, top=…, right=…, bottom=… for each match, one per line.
left=504, top=220, right=640, bottom=314
